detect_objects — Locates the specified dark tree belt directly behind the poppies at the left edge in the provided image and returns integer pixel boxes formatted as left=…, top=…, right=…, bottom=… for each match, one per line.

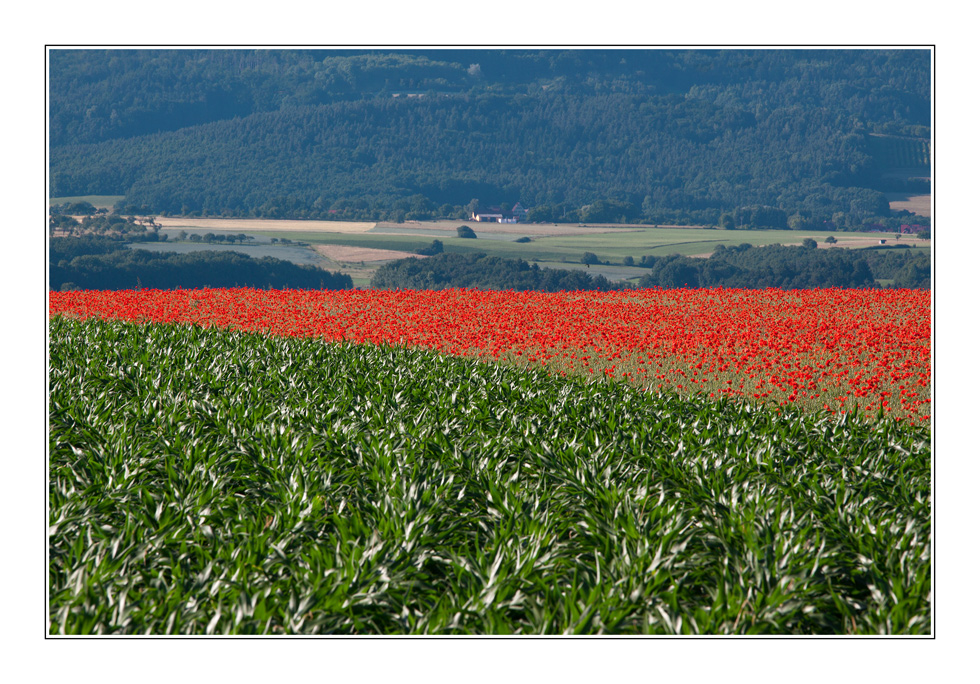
left=48, top=236, right=353, bottom=290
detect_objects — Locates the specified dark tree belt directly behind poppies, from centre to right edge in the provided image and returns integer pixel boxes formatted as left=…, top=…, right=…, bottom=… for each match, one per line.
left=371, top=241, right=931, bottom=292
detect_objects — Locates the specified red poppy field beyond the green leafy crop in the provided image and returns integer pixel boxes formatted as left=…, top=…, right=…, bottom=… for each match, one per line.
left=50, top=289, right=931, bottom=421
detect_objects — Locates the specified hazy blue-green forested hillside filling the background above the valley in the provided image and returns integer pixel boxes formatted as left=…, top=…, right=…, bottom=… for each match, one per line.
left=49, top=49, right=931, bottom=230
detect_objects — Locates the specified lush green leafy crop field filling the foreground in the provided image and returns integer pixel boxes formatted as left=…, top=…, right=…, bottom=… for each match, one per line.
left=49, top=318, right=932, bottom=634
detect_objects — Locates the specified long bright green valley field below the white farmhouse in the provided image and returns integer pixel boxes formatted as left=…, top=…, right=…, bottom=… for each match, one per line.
left=255, top=224, right=930, bottom=264
